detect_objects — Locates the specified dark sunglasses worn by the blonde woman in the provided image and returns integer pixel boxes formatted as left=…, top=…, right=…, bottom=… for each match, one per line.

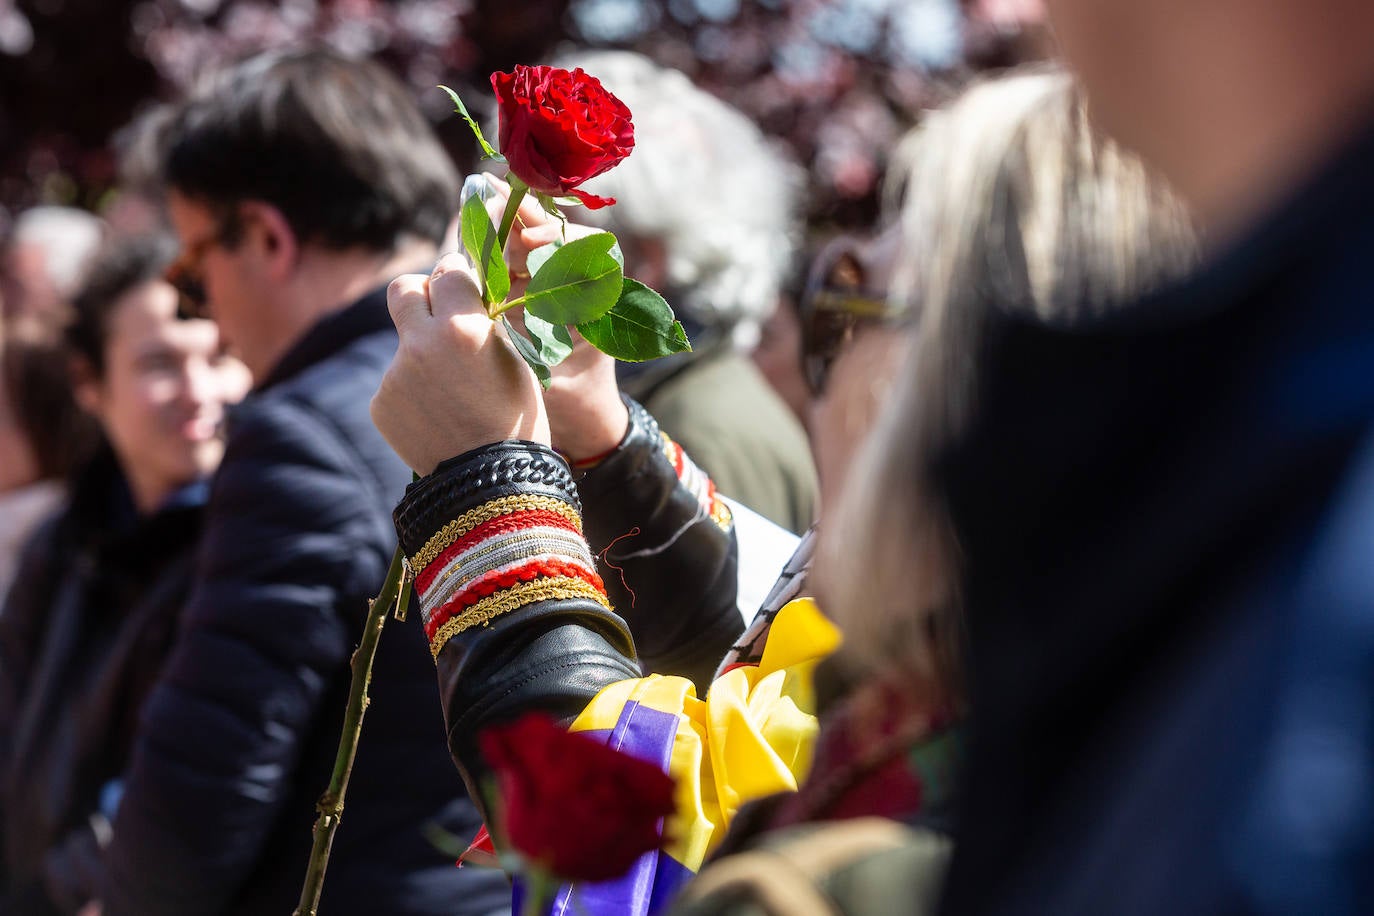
left=797, top=239, right=897, bottom=397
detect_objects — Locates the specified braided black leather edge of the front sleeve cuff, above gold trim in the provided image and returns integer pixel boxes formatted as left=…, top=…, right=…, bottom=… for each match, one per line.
left=392, top=439, right=581, bottom=556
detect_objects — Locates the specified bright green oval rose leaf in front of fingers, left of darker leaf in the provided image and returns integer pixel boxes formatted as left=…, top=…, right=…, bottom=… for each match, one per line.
left=521, top=232, right=624, bottom=324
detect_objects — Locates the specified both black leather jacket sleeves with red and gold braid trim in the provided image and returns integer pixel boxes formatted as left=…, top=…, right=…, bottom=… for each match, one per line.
left=396, top=414, right=743, bottom=818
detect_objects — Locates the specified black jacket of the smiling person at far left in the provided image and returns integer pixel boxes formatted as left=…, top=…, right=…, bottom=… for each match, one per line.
left=0, top=452, right=206, bottom=916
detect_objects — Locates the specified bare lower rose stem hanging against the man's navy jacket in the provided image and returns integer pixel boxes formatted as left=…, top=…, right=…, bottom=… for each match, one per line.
left=294, top=547, right=409, bottom=916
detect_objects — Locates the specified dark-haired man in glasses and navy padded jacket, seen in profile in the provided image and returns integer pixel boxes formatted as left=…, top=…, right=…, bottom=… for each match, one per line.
left=104, top=51, right=508, bottom=916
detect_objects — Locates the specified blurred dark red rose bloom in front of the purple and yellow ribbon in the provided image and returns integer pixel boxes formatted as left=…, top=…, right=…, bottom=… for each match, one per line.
left=481, top=713, right=673, bottom=882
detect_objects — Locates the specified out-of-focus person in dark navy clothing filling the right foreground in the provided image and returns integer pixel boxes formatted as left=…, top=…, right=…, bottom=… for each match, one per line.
left=941, top=0, right=1374, bottom=915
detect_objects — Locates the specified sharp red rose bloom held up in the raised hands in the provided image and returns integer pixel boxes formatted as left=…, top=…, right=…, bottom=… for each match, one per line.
left=492, top=66, right=635, bottom=210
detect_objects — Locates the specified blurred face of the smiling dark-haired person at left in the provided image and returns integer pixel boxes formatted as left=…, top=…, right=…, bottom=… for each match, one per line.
left=77, top=280, right=249, bottom=512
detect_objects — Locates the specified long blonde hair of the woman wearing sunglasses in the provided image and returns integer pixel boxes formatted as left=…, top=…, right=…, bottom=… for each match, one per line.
left=818, top=71, right=1195, bottom=694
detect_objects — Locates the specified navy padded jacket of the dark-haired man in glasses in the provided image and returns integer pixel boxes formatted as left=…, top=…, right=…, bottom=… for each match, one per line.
left=104, top=290, right=510, bottom=916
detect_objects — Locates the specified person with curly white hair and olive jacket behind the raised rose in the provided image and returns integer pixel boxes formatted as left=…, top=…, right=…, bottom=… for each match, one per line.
left=556, top=51, right=816, bottom=533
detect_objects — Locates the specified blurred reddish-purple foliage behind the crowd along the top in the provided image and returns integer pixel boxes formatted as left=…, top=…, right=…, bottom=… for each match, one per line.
left=0, top=0, right=1046, bottom=240
